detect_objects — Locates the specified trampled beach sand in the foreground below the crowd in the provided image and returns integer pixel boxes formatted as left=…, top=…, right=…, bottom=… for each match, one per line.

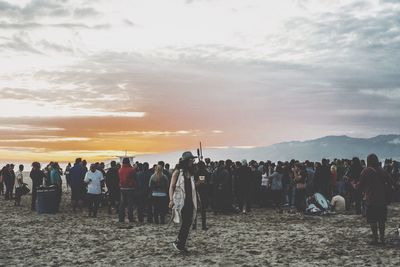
left=0, top=194, right=400, bottom=266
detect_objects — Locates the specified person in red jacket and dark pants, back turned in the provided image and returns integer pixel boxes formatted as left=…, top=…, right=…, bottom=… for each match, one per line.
left=118, top=158, right=136, bottom=223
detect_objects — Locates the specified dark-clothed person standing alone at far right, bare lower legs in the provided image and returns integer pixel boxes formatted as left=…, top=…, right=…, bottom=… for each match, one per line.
left=359, top=154, right=393, bottom=245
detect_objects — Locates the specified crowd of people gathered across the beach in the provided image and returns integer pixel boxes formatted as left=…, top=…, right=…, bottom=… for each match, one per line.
left=0, top=152, right=400, bottom=250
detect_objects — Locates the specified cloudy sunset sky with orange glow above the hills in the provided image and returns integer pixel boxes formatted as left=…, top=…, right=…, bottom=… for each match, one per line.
left=0, top=0, right=400, bottom=161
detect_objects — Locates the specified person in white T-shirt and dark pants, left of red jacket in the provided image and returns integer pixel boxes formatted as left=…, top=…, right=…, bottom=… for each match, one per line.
left=84, top=164, right=104, bottom=218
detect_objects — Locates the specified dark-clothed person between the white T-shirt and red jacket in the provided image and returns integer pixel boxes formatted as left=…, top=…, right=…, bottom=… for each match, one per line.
left=106, top=160, right=121, bottom=214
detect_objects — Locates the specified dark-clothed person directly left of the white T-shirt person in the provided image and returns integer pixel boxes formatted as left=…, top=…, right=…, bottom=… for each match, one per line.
left=69, top=158, right=86, bottom=212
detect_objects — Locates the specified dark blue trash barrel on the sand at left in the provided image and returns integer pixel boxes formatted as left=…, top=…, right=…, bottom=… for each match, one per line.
left=36, top=186, right=57, bottom=214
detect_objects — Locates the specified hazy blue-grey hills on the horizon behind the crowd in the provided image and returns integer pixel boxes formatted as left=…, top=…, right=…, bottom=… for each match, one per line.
left=137, top=135, right=400, bottom=164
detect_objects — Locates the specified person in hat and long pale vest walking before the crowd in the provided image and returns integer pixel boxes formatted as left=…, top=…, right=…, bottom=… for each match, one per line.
left=168, top=151, right=197, bottom=253
